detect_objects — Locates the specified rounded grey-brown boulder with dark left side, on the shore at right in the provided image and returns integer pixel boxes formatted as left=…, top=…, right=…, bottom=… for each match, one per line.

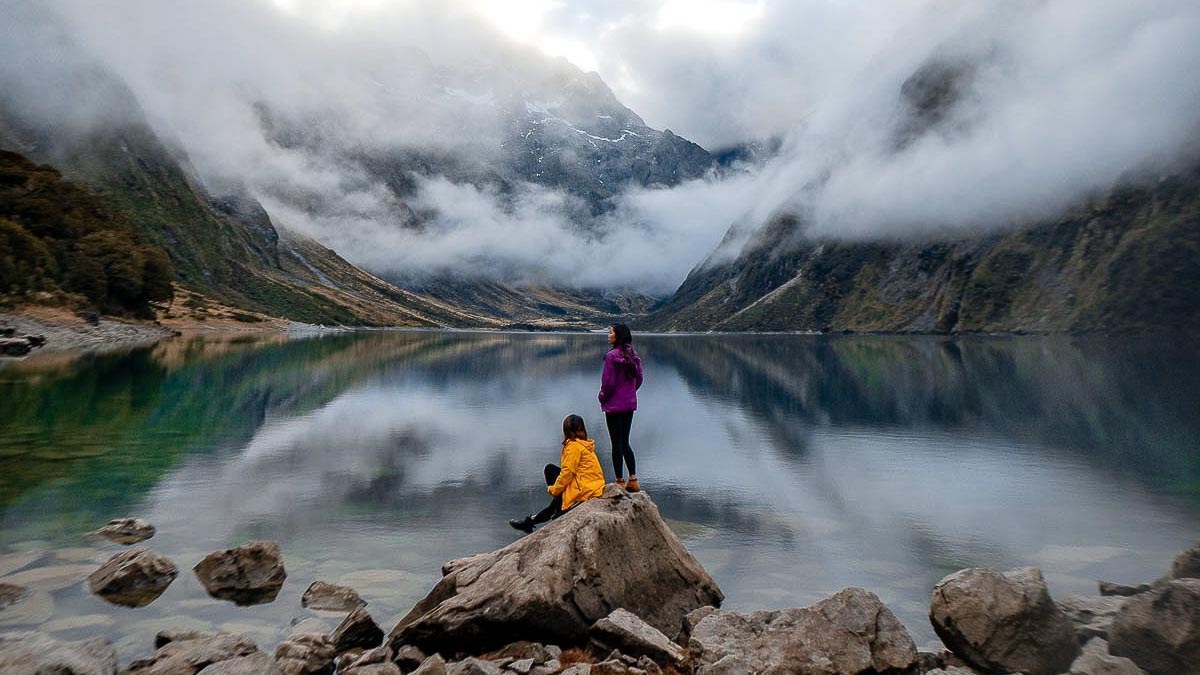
left=929, top=567, right=1079, bottom=675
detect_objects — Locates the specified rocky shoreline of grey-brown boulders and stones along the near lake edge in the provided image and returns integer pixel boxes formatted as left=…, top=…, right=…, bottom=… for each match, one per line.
left=0, top=485, right=1200, bottom=675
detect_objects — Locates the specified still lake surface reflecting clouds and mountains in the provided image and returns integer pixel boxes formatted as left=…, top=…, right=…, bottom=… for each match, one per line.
left=0, top=331, right=1200, bottom=663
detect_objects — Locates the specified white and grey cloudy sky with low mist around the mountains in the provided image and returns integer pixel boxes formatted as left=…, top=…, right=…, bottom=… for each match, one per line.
left=7, top=0, right=1200, bottom=294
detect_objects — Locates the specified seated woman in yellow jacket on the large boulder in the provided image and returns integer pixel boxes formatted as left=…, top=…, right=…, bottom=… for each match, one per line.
left=509, top=414, right=604, bottom=533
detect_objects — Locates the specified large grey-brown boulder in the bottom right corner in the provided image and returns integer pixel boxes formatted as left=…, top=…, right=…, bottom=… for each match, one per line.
left=1109, top=571, right=1200, bottom=675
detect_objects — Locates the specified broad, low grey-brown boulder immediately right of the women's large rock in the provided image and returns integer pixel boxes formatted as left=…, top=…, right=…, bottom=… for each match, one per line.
left=688, top=589, right=917, bottom=675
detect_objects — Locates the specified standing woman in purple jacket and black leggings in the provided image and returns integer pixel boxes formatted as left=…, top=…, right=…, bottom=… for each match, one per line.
left=599, top=323, right=642, bottom=492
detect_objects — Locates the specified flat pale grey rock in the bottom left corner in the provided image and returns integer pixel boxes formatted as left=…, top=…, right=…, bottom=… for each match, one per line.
left=0, top=633, right=116, bottom=675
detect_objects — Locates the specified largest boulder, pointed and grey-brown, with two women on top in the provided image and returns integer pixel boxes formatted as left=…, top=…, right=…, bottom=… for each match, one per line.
left=389, top=485, right=724, bottom=653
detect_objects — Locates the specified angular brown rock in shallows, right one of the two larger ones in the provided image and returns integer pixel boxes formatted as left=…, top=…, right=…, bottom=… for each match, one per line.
left=193, top=542, right=288, bottom=604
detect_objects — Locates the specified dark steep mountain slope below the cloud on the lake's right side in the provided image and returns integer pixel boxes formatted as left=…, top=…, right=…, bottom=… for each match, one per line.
left=646, top=169, right=1200, bottom=333
